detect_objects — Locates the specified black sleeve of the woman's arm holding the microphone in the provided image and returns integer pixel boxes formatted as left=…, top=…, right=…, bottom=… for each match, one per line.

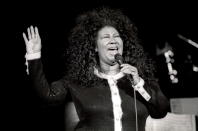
left=145, top=81, right=170, bottom=119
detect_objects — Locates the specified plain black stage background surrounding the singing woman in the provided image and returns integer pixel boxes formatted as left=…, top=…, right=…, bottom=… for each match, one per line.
left=2, top=0, right=198, bottom=131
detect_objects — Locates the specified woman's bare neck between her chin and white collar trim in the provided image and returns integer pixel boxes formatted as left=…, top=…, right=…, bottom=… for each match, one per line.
left=100, top=63, right=120, bottom=75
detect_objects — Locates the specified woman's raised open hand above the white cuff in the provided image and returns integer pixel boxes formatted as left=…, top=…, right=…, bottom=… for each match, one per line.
left=23, top=26, right=41, bottom=54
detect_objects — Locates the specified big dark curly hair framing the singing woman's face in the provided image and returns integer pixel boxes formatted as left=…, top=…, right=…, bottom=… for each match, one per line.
left=66, top=7, right=158, bottom=87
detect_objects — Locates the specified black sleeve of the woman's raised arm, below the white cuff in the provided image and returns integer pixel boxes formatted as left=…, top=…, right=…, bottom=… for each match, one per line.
left=28, top=59, right=69, bottom=102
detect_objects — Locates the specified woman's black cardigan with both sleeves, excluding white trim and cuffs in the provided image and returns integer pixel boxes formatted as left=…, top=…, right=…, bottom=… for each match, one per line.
left=28, top=59, right=169, bottom=131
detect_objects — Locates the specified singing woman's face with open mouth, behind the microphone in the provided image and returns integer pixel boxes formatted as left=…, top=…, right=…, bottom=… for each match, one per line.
left=96, top=26, right=123, bottom=64
